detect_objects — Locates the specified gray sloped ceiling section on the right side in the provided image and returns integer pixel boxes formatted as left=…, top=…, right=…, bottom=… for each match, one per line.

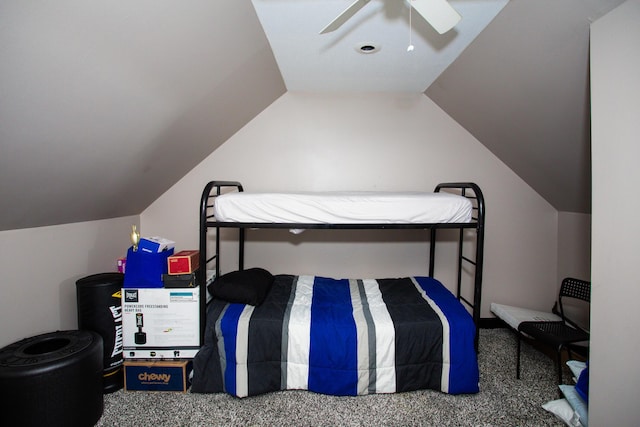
left=425, top=0, right=623, bottom=213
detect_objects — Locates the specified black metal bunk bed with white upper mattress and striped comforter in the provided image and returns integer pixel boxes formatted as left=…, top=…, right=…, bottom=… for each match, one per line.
left=192, top=181, right=485, bottom=397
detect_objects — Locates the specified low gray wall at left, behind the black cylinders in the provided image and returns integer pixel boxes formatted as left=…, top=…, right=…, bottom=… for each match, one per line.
left=0, top=216, right=139, bottom=346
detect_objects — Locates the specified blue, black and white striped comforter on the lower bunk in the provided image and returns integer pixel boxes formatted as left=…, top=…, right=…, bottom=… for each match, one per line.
left=191, top=275, right=479, bottom=397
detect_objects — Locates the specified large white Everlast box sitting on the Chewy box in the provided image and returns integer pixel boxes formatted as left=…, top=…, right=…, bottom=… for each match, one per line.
left=122, top=288, right=200, bottom=359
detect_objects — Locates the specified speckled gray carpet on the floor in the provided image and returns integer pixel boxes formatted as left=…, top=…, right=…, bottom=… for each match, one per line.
left=98, top=329, right=563, bottom=427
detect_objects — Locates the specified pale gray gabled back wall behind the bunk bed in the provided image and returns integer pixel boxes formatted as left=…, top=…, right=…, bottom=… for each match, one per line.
left=140, top=92, right=564, bottom=317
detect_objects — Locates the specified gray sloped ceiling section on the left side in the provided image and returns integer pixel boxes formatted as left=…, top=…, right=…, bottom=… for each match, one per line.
left=0, top=0, right=286, bottom=230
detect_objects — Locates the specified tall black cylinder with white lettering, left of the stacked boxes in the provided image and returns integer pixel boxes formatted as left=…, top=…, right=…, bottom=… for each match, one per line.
left=76, top=272, right=124, bottom=393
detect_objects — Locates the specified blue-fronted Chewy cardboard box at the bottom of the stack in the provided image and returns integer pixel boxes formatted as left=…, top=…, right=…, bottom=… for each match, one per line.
left=123, top=360, right=192, bottom=393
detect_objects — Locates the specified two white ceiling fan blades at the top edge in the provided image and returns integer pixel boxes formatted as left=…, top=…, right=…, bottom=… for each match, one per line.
left=320, top=0, right=462, bottom=34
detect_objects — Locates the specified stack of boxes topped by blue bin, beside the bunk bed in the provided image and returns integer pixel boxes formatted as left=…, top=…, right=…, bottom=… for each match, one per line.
left=122, top=237, right=200, bottom=391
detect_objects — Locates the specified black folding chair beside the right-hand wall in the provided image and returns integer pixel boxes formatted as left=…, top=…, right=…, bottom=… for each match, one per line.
left=516, top=278, right=591, bottom=384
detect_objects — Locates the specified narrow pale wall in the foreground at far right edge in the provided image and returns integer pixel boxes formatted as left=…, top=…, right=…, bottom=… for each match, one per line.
left=589, top=0, right=640, bottom=427
